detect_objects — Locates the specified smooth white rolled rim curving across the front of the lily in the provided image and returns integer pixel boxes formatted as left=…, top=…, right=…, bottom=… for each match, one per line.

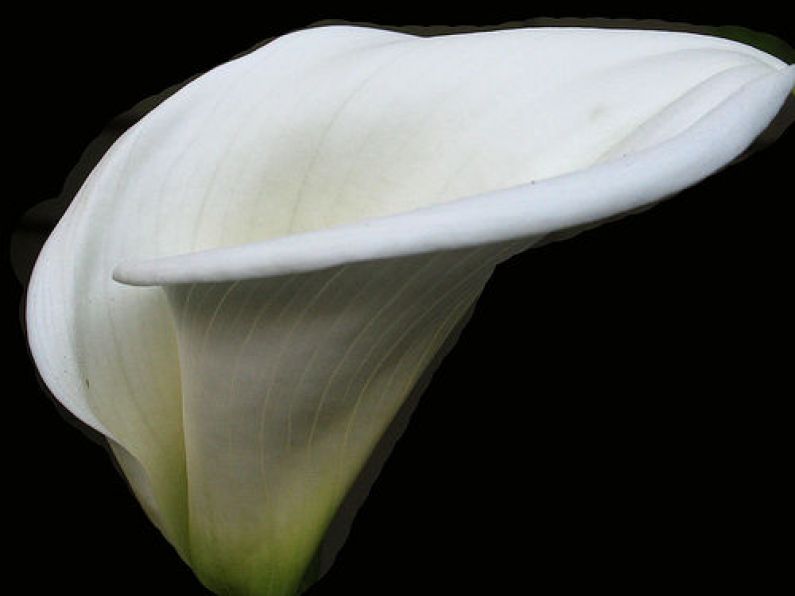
left=113, top=65, right=795, bottom=286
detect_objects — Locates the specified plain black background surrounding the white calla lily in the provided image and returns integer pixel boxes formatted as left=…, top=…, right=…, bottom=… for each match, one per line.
left=3, top=2, right=795, bottom=596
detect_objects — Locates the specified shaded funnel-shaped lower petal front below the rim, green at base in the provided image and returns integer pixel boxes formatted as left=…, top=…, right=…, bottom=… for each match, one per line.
left=163, top=245, right=518, bottom=594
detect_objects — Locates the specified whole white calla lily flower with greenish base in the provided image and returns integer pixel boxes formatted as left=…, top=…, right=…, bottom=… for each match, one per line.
left=27, top=26, right=795, bottom=595
